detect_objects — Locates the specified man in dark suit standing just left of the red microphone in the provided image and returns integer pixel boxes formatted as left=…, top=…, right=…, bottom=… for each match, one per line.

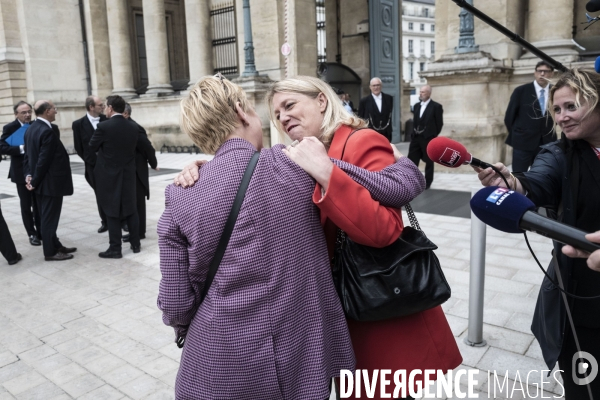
left=408, top=85, right=444, bottom=189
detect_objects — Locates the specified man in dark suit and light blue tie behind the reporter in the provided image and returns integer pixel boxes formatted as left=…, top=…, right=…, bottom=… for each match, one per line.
left=504, top=61, right=556, bottom=172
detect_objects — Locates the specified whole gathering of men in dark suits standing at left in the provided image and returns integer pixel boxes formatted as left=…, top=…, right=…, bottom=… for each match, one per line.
left=0, top=96, right=158, bottom=265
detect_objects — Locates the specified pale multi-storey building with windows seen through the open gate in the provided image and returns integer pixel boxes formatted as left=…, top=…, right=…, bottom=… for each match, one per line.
left=402, top=0, right=435, bottom=106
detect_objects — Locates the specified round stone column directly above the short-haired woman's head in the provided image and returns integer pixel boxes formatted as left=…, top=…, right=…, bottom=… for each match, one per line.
left=185, top=0, right=213, bottom=86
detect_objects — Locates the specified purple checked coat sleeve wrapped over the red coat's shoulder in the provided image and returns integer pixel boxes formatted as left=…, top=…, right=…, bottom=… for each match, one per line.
left=332, top=157, right=425, bottom=208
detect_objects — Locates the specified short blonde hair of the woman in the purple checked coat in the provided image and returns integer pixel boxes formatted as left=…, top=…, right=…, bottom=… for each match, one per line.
left=179, top=75, right=249, bottom=154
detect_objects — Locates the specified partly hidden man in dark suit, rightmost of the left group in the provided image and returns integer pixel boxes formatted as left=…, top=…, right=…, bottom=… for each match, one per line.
left=123, top=103, right=158, bottom=242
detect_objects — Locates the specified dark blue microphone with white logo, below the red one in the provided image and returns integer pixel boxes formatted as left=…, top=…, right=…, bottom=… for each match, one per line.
left=471, top=186, right=600, bottom=253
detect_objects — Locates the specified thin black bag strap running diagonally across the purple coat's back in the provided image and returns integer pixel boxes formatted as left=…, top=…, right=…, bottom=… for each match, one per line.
left=200, top=151, right=260, bottom=303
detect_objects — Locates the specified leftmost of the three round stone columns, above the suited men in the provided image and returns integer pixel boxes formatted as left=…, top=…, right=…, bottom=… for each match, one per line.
left=106, top=0, right=135, bottom=97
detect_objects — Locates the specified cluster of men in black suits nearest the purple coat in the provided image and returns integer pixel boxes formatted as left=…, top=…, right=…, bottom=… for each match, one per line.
left=72, top=96, right=158, bottom=258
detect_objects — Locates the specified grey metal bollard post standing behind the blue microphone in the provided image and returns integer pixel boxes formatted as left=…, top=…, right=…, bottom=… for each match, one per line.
left=464, top=187, right=487, bottom=347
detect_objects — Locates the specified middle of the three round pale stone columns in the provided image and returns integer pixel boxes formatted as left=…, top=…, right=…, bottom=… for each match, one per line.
left=142, top=0, right=173, bottom=94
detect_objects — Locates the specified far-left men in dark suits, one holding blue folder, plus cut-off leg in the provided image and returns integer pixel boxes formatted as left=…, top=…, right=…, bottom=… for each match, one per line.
left=0, top=100, right=77, bottom=264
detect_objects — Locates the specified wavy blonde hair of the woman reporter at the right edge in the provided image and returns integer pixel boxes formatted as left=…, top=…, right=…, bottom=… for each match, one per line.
left=548, top=68, right=600, bottom=125
